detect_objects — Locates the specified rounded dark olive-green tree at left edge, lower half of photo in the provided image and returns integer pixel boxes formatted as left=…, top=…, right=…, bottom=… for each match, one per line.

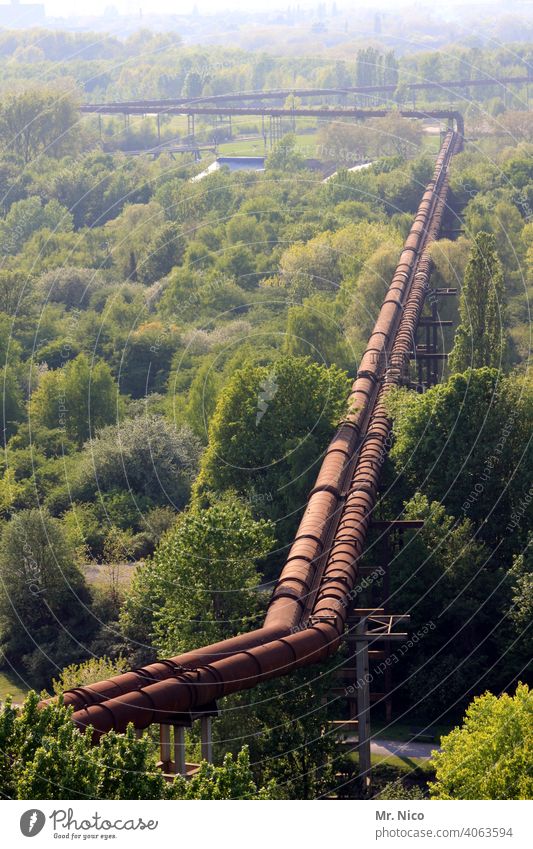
left=0, top=509, right=95, bottom=683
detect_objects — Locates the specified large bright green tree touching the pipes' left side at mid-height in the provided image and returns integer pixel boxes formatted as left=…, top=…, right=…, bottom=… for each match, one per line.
left=196, top=356, right=349, bottom=535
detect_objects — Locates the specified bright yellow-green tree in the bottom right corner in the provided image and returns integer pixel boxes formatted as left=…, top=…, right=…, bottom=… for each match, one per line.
left=430, top=684, right=533, bottom=799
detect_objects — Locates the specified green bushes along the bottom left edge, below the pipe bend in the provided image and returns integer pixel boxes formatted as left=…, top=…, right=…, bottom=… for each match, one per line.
left=0, top=693, right=277, bottom=799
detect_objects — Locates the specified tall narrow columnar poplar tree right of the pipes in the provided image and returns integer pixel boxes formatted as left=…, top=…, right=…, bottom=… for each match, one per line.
left=450, top=232, right=507, bottom=372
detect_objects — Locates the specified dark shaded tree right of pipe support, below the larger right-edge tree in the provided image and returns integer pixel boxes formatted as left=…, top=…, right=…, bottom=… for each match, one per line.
left=391, top=493, right=502, bottom=715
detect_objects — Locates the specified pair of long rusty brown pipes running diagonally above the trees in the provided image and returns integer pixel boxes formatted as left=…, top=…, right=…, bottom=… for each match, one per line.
left=52, top=131, right=461, bottom=738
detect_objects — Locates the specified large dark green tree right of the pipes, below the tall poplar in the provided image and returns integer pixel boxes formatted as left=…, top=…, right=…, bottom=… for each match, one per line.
left=389, top=368, right=533, bottom=554
